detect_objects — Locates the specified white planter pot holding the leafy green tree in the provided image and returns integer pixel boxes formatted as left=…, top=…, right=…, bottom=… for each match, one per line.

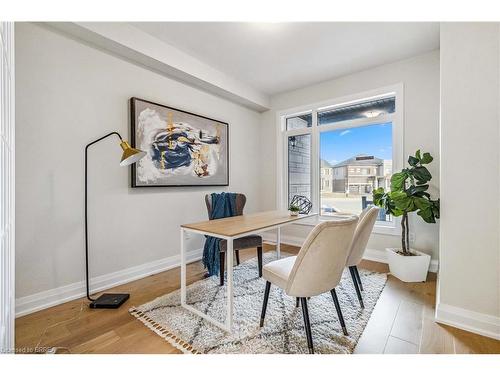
left=386, top=248, right=431, bottom=283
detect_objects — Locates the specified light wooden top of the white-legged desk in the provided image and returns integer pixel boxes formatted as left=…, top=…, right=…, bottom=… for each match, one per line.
left=181, top=211, right=316, bottom=237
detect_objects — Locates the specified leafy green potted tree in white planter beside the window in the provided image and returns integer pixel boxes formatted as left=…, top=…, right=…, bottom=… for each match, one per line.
left=373, top=150, right=439, bottom=282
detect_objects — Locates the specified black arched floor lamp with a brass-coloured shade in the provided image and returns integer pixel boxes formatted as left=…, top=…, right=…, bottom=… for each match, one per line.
left=85, top=132, right=146, bottom=309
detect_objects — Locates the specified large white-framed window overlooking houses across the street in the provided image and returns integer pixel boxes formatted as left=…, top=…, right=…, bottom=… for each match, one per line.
left=278, top=85, right=403, bottom=234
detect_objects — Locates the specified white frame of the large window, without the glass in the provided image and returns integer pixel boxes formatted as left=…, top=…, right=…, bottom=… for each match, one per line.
left=276, top=83, right=405, bottom=235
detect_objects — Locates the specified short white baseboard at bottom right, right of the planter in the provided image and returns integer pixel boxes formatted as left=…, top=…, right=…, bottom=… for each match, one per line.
left=435, top=302, right=500, bottom=340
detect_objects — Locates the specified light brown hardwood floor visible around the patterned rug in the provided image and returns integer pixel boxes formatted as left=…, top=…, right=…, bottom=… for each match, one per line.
left=16, top=245, right=500, bottom=354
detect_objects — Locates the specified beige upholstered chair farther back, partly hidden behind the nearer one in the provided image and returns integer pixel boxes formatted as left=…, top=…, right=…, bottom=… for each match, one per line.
left=346, top=207, right=380, bottom=308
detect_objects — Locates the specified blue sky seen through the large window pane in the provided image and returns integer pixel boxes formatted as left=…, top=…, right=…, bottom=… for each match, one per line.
left=320, top=122, right=392, bottom=165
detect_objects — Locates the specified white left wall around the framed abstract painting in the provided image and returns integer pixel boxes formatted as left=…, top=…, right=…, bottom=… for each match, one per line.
left=16, top=23, right=260, bottom=309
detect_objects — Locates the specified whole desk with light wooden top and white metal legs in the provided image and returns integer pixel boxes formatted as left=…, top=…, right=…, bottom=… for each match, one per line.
left=181, top=211, right=316, bottom=332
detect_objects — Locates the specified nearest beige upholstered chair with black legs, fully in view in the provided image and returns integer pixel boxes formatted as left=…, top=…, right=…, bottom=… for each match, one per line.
left=260, top=216, right=358, bottom=353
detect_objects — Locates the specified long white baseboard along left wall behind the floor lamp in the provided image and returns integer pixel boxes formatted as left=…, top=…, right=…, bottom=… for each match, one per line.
left=16, top=249, right=203, bottom=317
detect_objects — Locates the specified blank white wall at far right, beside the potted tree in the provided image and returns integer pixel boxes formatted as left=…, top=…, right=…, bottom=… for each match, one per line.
left=436, top=23, right=500, bottom=339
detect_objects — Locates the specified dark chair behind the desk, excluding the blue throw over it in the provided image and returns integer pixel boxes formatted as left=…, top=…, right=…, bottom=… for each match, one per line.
left=205, top=193, right=262, bottom=286
